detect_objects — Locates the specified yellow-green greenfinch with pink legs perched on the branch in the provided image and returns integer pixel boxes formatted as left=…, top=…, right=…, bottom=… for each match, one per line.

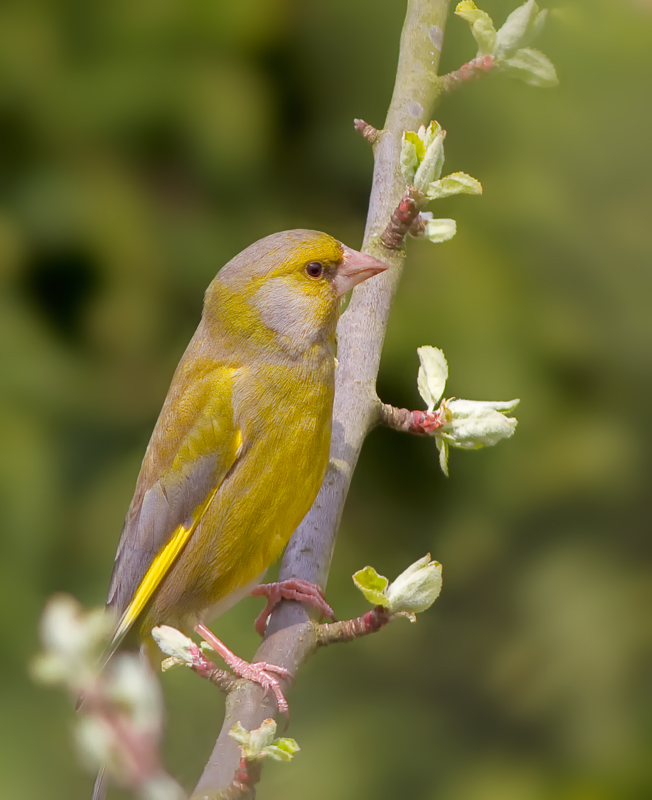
left=102, top=230, right=387, bottom=710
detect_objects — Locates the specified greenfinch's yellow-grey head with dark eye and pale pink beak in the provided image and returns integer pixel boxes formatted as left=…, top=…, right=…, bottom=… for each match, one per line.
left=204, top=230, right=387, bottom=350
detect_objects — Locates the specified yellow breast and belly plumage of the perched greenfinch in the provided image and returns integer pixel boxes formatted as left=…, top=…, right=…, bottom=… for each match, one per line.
left=140, top=354, right=334, bottom=633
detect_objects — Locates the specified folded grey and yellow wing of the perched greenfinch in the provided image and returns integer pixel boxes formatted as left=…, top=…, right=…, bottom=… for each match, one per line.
left=108, top=366, right=242, bottom=651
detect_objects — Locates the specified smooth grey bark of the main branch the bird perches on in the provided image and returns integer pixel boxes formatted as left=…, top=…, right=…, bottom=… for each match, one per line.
left=193, top=0, right=450, bottom=798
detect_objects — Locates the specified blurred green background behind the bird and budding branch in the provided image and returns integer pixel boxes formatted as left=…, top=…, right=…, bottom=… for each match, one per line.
left=0, top=0, right=652, bottom=800
